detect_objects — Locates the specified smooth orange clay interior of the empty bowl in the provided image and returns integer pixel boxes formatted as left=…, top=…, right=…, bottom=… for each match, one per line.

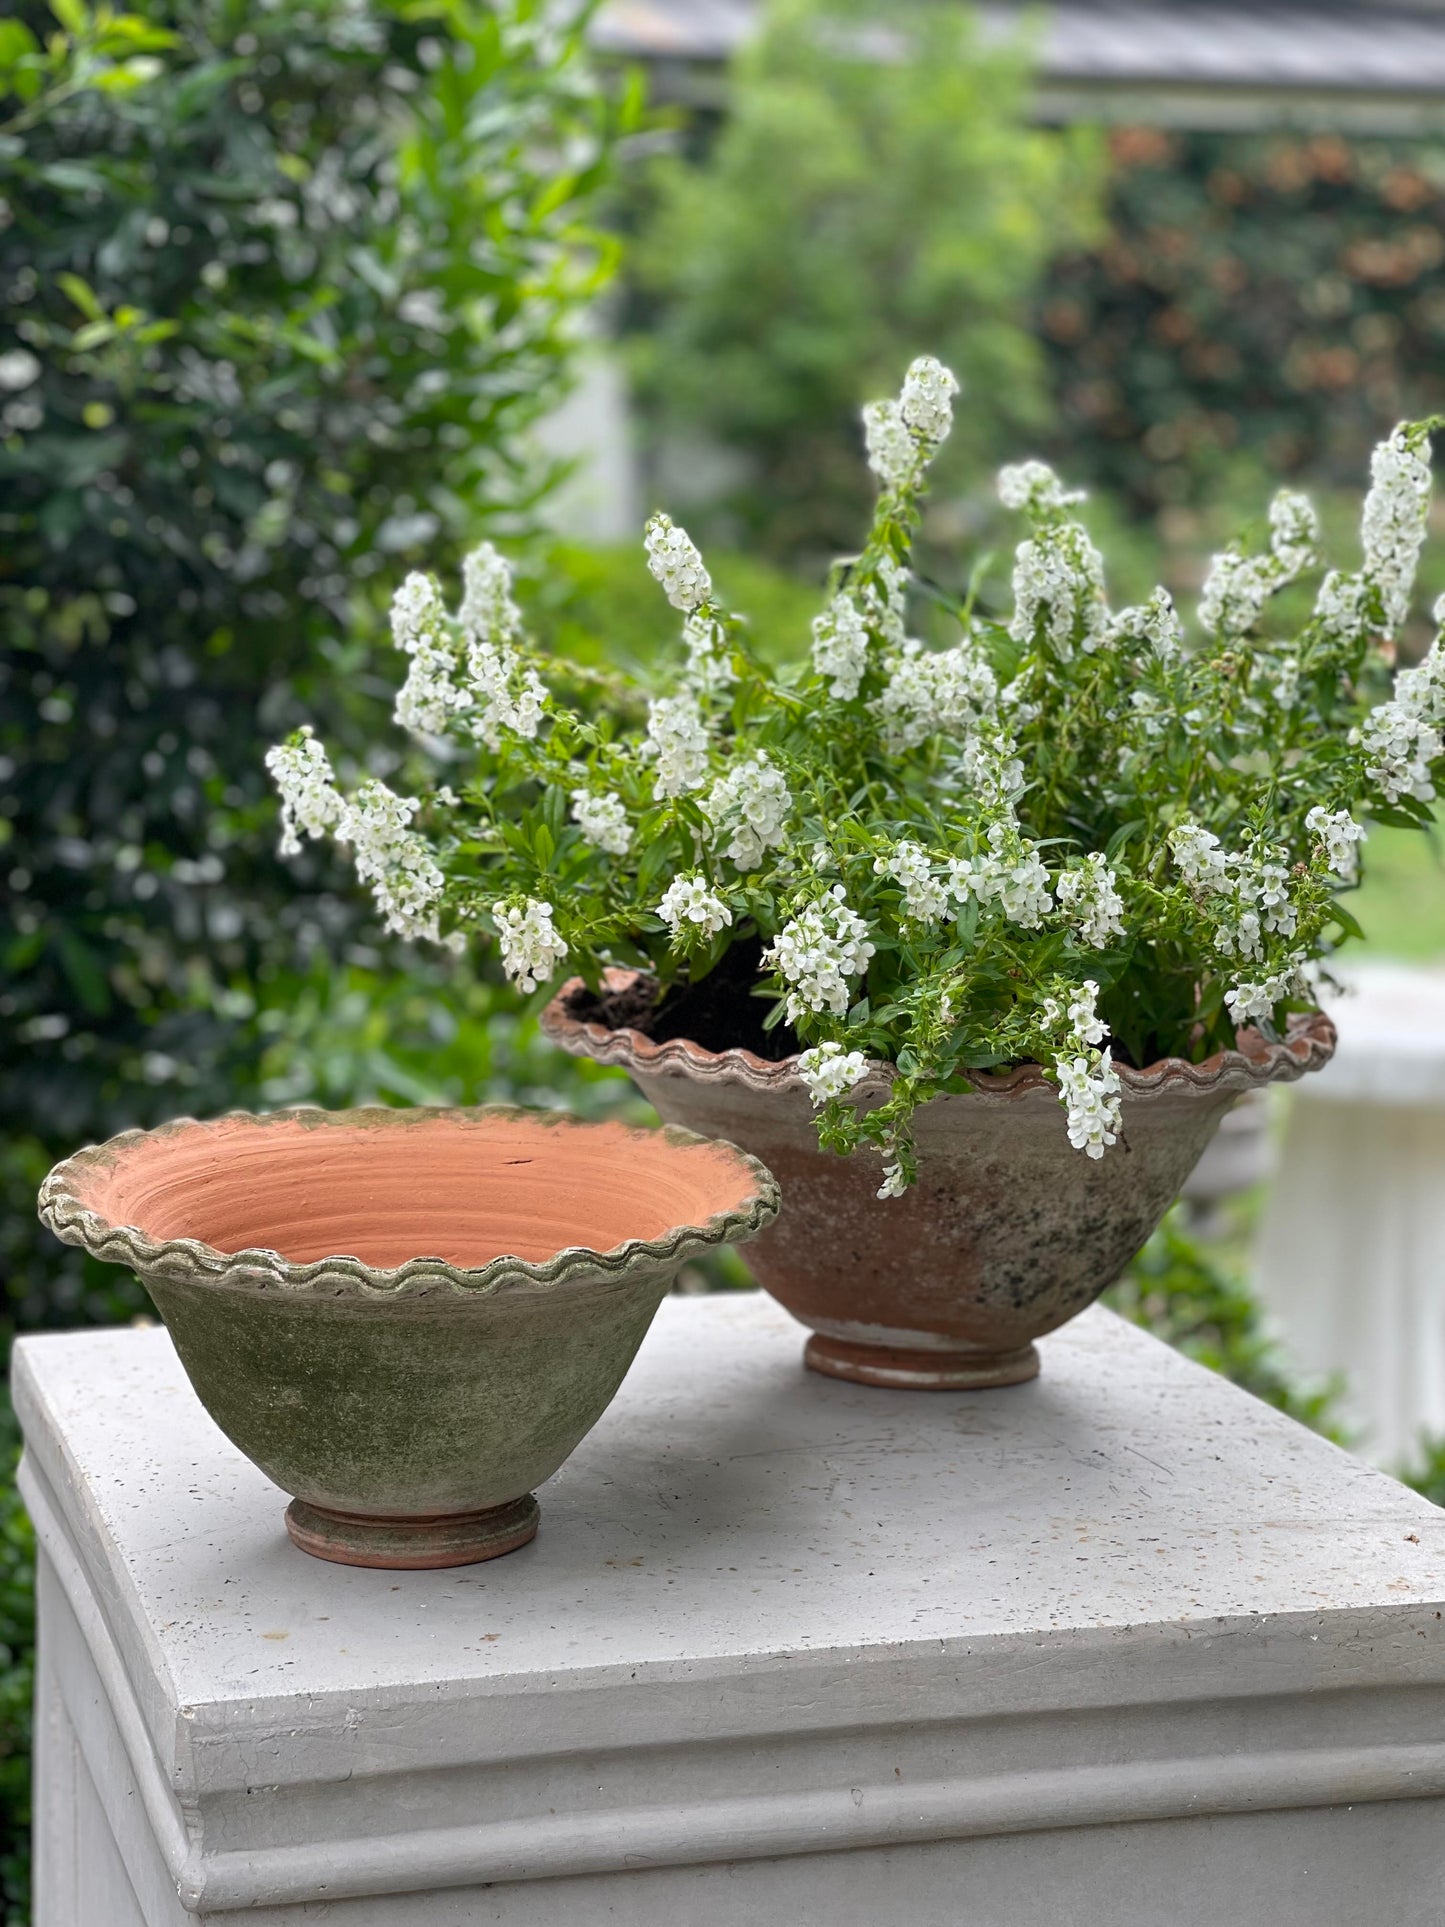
left=75, top=1112, right=757, bottom=1270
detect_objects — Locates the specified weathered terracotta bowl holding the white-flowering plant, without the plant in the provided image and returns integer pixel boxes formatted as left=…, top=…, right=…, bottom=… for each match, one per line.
left=543, top=973, right=1335, bottom=1389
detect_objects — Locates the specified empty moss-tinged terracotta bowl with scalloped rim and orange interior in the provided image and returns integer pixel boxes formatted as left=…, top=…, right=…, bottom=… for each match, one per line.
left=40, top=1106, right=778, bottom=1567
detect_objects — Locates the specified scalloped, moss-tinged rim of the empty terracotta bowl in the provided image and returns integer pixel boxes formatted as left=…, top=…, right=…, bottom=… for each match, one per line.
left=39, top=1104, right=782, bottom=1299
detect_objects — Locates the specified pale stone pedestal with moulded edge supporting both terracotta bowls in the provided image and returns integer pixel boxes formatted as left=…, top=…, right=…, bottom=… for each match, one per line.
left=15, top=1297, right=1445, bottom=1927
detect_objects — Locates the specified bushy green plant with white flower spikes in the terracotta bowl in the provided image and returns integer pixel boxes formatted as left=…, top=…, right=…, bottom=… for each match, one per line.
left=266, top=356, right=1445, bottom=1197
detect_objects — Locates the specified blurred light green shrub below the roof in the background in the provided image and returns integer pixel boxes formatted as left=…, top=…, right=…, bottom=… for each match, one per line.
left=634, top=0, right=1100, bottom=561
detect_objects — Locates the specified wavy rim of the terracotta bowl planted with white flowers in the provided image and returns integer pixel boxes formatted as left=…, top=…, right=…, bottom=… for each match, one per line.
left=541, top=969, right=1335, bottom=1104
